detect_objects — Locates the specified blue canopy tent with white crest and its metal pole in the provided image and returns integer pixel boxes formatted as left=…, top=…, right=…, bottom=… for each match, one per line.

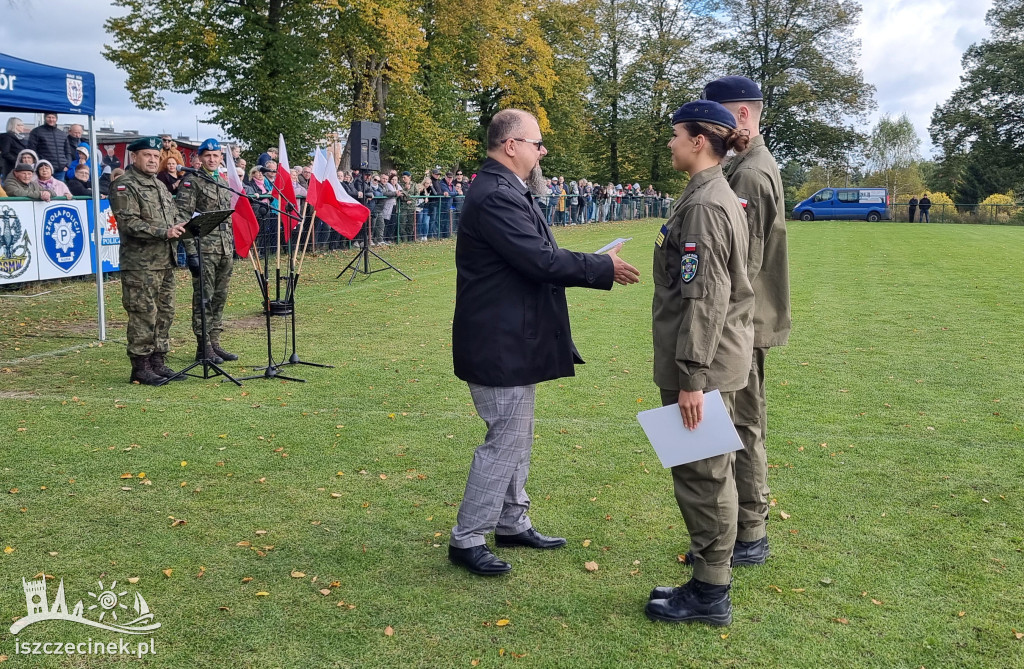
left=0, top=53, right=106, bottom=341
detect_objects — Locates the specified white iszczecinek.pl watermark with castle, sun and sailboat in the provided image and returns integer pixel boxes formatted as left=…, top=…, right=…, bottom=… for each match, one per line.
left=10, top=575, right=160, bottom=658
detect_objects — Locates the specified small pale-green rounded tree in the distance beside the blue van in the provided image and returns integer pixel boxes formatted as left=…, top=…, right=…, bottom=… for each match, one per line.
left=864, top=114, right=925, bottom=202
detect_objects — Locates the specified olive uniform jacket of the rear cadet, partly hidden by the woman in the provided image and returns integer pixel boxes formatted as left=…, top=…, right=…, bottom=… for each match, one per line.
left=726, top=135, right=793, bottom=348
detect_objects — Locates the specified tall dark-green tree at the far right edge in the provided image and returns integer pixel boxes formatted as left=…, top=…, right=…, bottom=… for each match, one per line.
left=929, top=0, right=1024, bottom=204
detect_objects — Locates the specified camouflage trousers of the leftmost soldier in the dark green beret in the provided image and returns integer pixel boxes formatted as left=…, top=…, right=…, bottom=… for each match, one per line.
left=120, top=268, right=174, bottom=357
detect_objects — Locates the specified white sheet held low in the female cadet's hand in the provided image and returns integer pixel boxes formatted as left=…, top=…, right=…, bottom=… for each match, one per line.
left=637, top=390, right=743, bottom=468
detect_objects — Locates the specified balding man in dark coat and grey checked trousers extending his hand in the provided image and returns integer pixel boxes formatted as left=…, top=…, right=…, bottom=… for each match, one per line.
left=449, top=110, right=639, bottom=576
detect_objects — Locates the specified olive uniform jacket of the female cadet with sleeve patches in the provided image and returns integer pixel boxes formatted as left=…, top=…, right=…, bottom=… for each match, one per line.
left=652, top=165, right=754, bottom=391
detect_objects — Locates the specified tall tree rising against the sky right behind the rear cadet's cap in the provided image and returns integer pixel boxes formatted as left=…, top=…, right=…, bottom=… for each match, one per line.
left=716, top=0, right=874, bottom=163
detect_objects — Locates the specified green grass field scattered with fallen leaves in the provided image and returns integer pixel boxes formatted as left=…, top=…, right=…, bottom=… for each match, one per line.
left=0, top=221, right=1024, bottom=668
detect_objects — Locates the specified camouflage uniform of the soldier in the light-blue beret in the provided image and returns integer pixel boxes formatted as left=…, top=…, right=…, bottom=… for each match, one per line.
left=175, top=173, right=234, bottom=346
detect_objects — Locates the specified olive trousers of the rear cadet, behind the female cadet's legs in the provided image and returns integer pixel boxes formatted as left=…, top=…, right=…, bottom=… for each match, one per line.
left=734, top=348, right=771, bottom=541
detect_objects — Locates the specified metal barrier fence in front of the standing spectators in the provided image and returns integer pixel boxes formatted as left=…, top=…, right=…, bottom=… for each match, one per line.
left=256, top=196, right=672, bottom=255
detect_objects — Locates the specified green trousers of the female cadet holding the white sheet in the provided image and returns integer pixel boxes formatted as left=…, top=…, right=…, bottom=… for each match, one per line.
left=662, top=388, right=738, bottom=585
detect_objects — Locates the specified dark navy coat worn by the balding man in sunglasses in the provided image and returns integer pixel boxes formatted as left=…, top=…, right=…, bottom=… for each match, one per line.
left=452, top=160, right=614, bottom=386
